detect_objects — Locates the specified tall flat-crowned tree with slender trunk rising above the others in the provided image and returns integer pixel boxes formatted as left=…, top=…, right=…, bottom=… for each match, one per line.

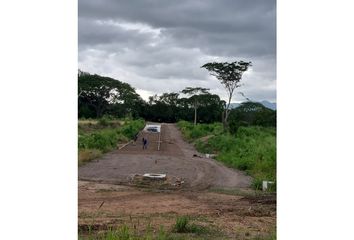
left=201, top=61, right=252, bottom=130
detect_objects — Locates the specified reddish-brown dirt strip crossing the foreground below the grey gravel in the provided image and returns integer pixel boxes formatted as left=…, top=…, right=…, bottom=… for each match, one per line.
left=78, top=181, right=276, bottom=239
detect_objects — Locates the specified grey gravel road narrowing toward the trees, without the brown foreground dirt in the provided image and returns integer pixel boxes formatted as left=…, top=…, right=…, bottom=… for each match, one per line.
left=79, top=124, right=251, bottom=190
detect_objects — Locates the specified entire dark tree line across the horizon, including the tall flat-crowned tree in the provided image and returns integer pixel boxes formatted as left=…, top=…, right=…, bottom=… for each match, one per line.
left=78, top=61, right=276, bottom=132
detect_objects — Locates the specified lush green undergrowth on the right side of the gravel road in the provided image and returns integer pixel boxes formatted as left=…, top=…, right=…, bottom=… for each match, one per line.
left=177, top=121, right=276, bottom=189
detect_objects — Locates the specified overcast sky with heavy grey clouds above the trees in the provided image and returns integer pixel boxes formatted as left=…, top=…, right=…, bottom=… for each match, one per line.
left=78, top=0, right=276, bottom=102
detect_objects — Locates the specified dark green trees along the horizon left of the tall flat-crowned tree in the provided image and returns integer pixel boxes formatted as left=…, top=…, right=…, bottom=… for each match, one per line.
left=78, top=71, right=225, bottom=123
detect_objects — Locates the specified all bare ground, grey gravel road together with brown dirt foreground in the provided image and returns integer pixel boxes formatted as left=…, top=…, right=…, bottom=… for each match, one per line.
left=78, top=124, right=276, bottom=239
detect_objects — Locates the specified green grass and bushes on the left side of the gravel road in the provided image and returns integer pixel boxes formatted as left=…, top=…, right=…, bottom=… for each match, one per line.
left=78, top=116, right=145, bottom=165
